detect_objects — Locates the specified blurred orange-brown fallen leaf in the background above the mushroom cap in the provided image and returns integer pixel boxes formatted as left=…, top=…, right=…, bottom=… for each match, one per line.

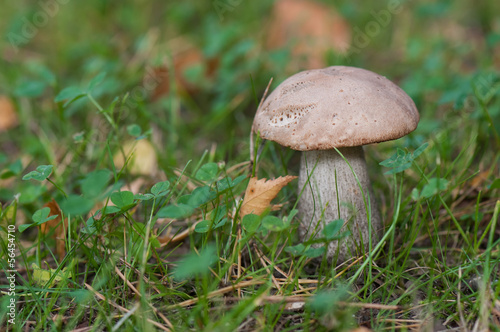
left=266, top=0, right=351, bottom=70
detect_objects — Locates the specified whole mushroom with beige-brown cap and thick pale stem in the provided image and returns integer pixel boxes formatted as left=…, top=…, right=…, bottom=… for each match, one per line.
left=252, top=66, right=419, bottom=262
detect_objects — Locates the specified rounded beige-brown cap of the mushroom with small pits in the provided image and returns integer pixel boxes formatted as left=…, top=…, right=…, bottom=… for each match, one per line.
left=252, top=66, right=419, bottom=151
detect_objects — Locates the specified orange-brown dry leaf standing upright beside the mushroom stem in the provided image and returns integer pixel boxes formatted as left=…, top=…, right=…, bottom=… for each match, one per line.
left=240, top=175, right=297, bottom=218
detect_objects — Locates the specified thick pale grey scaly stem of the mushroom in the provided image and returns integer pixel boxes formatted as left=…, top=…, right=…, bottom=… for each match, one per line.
left=298, top=146, right=382, bottom=262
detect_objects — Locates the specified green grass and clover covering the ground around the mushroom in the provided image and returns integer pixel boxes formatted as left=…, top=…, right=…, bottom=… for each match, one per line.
left=0, top=0, right=500, bottom=331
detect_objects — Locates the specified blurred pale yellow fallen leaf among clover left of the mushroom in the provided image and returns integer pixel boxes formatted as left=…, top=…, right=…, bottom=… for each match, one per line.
left=113, top=139, right=158, bottom=175
